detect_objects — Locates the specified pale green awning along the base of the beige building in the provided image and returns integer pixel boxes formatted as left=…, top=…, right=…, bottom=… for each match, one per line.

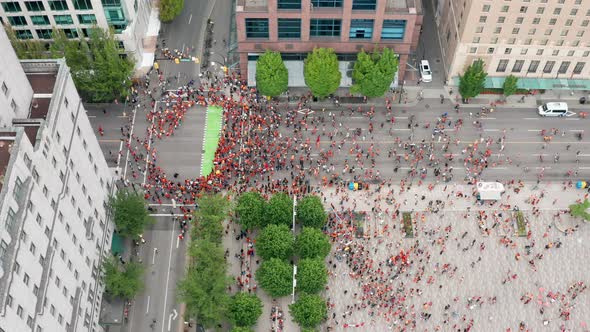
left=453, top=76, right=590, bottom=91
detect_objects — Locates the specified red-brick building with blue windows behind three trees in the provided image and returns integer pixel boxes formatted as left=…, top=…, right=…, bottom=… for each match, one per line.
left=236, top=0, right=423, bottom=86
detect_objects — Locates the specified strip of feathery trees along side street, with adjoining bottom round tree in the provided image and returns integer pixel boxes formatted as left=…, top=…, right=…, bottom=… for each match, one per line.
left=178, top=194, right=262, bottom=331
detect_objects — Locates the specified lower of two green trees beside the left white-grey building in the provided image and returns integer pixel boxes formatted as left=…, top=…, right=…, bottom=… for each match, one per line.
left=102, top=256, right=143, bottom=299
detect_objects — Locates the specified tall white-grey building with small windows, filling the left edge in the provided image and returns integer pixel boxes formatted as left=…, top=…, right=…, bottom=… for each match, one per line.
left=0, top=24, right=113, bottom=332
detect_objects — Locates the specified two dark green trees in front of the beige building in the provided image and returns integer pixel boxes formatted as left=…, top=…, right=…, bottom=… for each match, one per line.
left=459, top=59, right=518, bottom=101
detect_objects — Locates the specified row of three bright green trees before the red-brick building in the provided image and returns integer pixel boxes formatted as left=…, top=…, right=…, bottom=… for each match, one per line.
left=256, top=48, right=398, bottom=98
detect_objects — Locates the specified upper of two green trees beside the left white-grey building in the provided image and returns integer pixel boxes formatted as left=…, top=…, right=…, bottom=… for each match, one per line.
left=109, top=189, right=153, bottom=239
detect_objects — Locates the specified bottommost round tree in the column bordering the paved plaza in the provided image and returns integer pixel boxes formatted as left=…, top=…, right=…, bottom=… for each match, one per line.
left=289, top=293, right=328, bottom=328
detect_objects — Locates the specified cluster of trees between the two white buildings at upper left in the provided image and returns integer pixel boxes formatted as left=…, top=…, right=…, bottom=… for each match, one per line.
left=5, top=26, right=134, bottom=102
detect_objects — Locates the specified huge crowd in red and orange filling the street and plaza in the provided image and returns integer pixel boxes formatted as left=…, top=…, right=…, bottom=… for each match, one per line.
left=113, top=57, right=588, bottom=331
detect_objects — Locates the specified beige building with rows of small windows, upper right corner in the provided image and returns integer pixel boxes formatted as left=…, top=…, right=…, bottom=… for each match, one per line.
left=435, top=0, right=590, bottom=90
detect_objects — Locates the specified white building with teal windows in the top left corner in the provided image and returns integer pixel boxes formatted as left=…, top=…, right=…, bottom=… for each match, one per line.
left=0, top=0, right=160, bottom=67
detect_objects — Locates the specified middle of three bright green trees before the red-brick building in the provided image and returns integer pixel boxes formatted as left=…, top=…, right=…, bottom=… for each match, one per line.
left=303, top=48, right=342, bottom=98
